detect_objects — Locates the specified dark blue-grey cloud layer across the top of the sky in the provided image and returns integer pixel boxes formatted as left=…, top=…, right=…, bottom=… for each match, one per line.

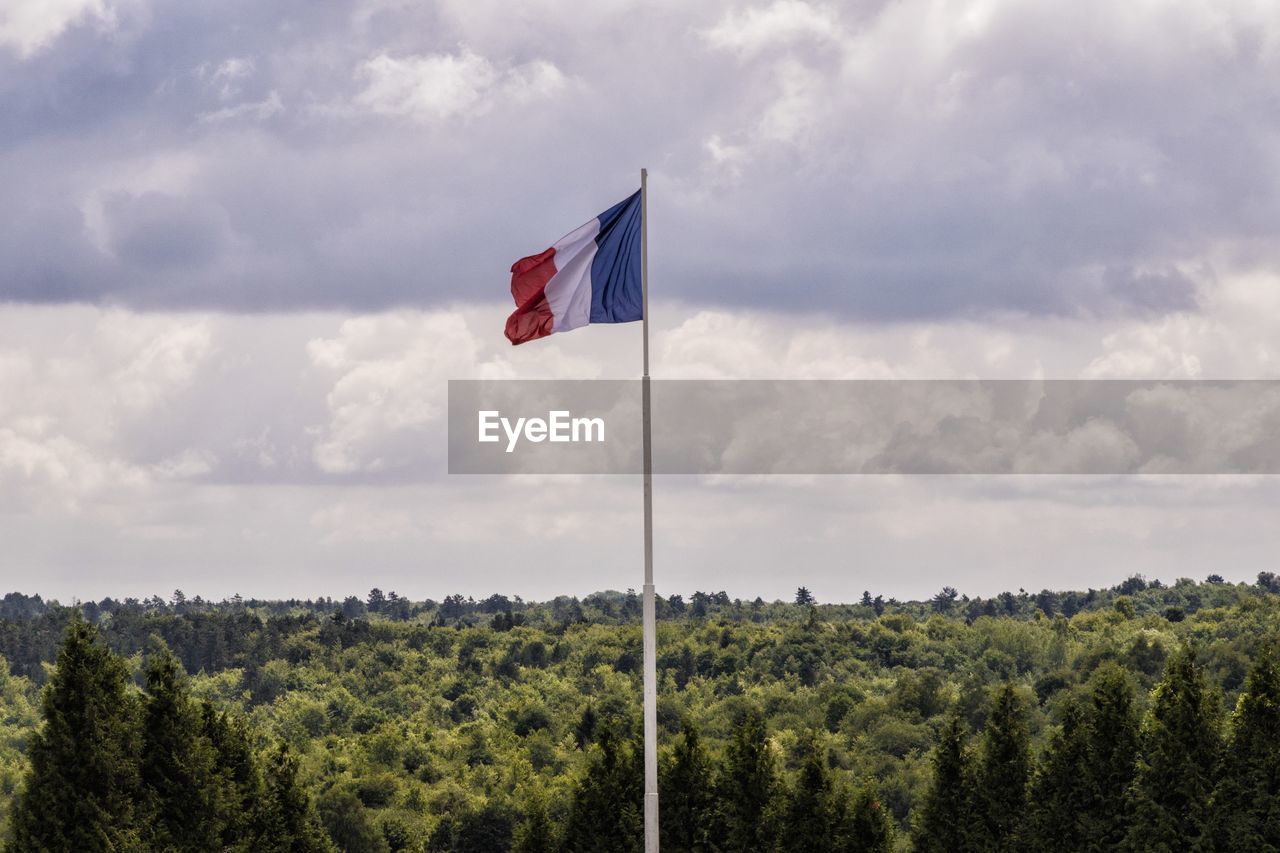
left=0, top=0, right=1280, bottom=319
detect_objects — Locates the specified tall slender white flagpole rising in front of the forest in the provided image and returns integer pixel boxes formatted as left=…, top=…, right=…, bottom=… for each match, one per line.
left=640, top=169, right=658, bottom=853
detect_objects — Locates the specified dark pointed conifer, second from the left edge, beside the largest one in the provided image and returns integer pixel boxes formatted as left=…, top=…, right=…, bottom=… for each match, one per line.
left=140, top=638, right=223, bottom=850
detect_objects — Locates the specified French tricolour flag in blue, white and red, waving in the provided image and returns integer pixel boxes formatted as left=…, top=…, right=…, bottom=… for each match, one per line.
left=507, top=192, right=644, bottom=345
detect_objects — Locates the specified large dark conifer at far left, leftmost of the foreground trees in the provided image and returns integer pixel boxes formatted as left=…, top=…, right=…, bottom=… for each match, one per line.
left=9, top=612, right=138, bottom=853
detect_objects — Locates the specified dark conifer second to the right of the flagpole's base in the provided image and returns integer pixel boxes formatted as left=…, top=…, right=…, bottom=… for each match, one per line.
left=716, top=708, right=778, bottom=853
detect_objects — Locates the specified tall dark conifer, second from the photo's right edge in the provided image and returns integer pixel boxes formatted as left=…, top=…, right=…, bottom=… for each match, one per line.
left=1129, top=648, right=1221, bottom=853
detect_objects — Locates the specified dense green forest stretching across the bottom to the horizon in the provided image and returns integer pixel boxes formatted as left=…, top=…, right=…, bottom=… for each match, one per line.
left=0, top=573, right=1280, bottom=853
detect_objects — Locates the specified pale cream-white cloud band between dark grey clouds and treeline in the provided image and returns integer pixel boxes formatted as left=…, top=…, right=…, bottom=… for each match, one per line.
left=0, top=298, right=1280, bottom=599
